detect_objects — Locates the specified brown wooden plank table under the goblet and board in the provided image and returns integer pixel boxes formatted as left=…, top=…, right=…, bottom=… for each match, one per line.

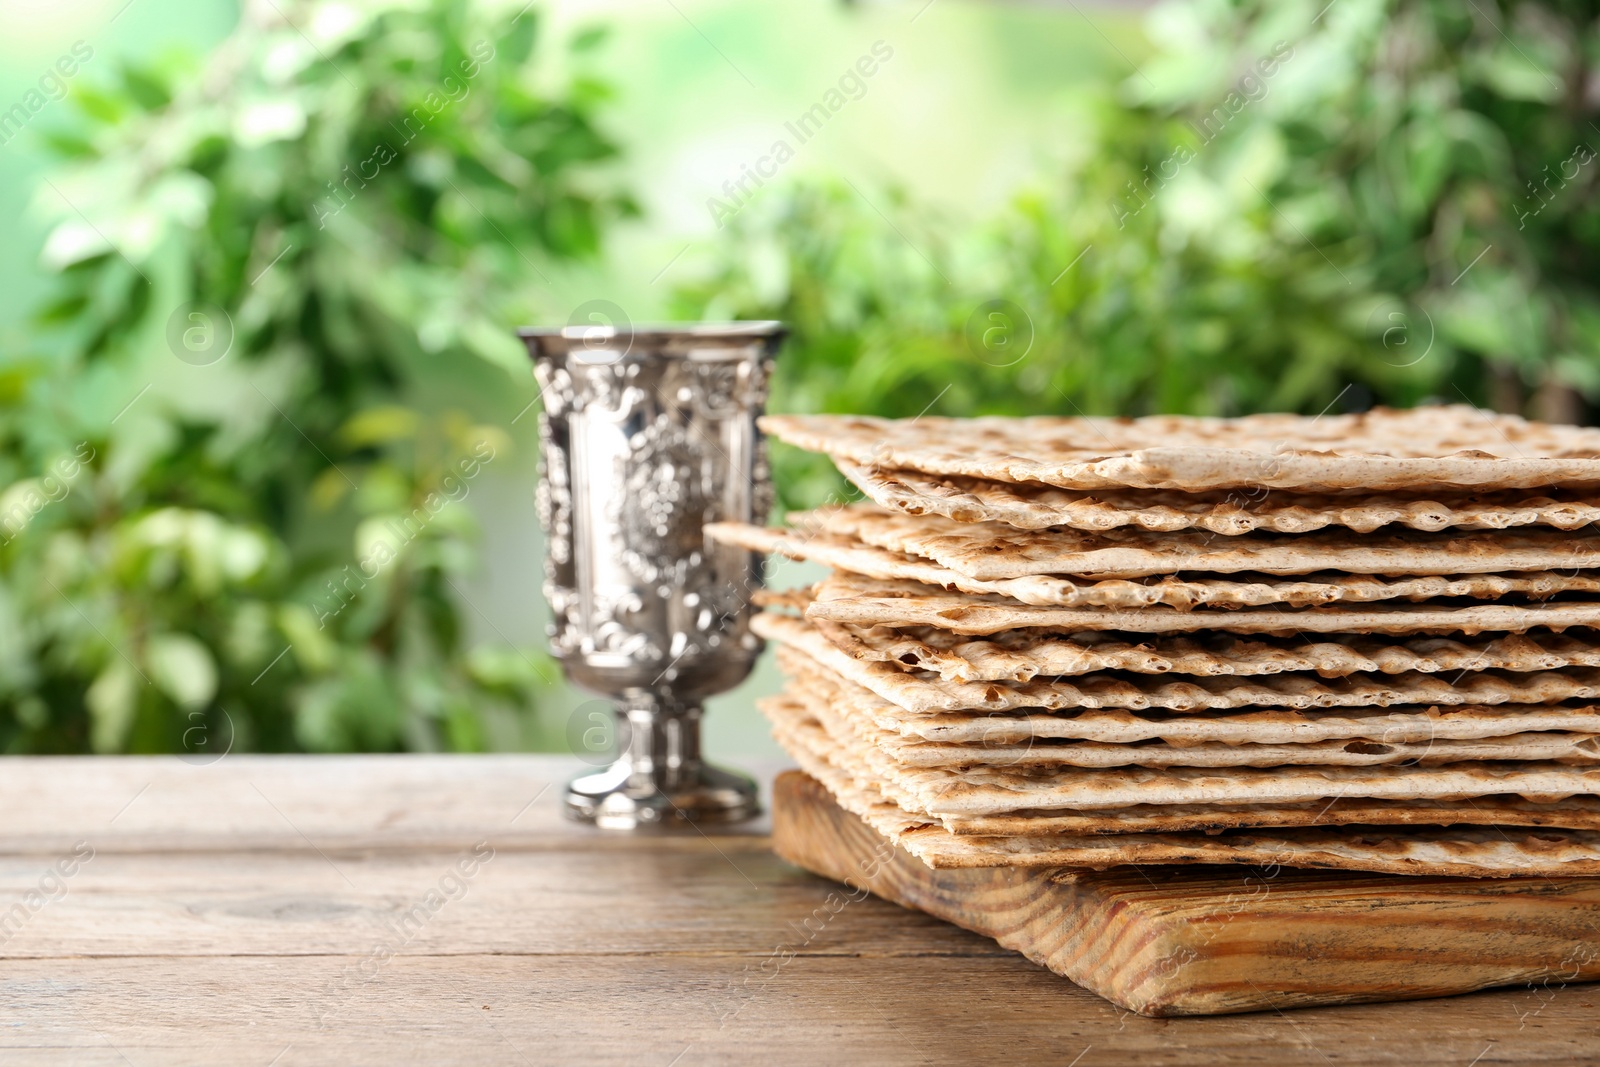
left=0, top=757, right=1600, bottom=1067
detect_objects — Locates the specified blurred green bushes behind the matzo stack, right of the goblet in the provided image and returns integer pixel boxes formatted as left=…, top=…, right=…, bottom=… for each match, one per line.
left=680, top=0, right=1600, bottom=507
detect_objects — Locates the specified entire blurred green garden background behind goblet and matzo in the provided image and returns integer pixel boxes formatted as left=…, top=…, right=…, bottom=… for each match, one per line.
left=0, top=0, right=1600, bottom=761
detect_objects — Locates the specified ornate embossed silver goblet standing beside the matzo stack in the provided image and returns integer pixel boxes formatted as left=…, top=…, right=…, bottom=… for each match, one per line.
left=520, top=322, right=784, bottom=829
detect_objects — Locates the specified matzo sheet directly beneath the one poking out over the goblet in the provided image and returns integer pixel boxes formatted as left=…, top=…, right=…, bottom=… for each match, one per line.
left=806, top=574, right=1600, bottom=638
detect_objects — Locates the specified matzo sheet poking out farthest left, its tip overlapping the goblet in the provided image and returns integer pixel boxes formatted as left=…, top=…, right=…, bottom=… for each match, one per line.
left=706, top=523, right=1600, bottom=611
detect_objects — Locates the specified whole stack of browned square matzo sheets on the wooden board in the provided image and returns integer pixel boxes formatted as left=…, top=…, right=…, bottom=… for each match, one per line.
left=710, top=408, right=1600, bottom=875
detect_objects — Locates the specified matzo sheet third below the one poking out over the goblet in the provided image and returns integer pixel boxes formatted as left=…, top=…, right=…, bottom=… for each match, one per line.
left=750, top=613, right=1600, bottom=712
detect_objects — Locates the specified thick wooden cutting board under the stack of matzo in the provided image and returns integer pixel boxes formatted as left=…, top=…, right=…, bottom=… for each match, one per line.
left=773, top=771, right=1600, bottom=1016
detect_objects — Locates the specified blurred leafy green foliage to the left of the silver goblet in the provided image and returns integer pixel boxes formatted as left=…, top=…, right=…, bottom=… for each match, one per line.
left=0, top=0, right=635, bottom=757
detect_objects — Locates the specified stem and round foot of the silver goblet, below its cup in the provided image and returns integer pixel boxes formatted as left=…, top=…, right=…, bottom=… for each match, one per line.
left=566, top=693, right=760, bottom=830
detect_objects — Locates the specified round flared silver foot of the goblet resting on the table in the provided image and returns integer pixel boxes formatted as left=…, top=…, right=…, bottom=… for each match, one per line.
left=566, top=760, right=762, bottom=830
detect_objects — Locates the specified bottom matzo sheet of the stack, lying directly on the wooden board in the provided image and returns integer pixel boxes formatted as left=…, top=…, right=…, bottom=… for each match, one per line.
left=755, top=704, right=1600, bottom=877
